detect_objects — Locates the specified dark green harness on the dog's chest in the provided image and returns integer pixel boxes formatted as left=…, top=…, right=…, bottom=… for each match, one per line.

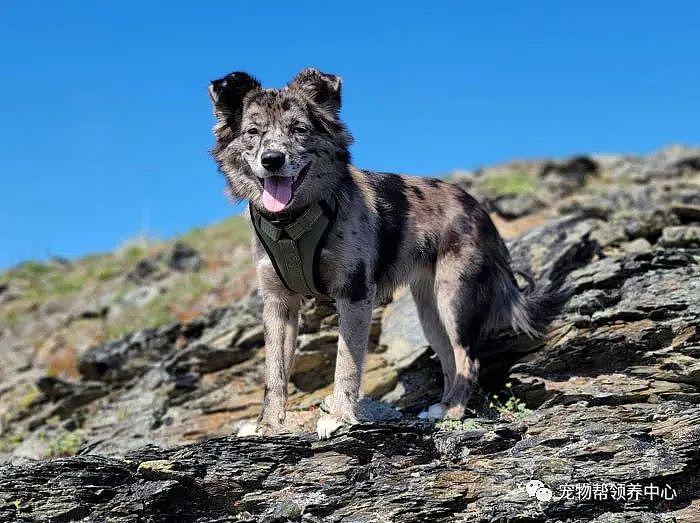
left=250, top=198, right=337, bottom=296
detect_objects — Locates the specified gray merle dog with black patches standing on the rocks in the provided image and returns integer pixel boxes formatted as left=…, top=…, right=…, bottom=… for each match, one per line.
left=209, top=68, right=552, bottom=439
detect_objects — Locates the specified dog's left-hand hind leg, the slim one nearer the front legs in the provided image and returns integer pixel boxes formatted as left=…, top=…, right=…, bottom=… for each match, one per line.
left=411, top=271, right=456, bottom=417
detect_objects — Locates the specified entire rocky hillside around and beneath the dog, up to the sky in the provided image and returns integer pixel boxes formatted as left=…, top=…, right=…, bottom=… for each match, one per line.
left=0, top=148, right=700, bottom=522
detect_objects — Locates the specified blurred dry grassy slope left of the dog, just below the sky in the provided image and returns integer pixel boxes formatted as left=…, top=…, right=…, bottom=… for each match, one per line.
left=0, top=216, right=254, bottom=356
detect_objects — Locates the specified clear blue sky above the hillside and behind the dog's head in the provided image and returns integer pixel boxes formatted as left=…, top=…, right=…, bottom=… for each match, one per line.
left=0, top=1, right=700, bottom=267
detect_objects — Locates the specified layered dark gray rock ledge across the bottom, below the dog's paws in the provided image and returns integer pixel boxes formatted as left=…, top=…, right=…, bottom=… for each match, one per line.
left=0, top=410, right=700, bottom=522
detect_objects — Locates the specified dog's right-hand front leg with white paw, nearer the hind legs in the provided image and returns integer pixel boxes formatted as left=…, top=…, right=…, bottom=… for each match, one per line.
left=316, top=293, right=374, bottom=439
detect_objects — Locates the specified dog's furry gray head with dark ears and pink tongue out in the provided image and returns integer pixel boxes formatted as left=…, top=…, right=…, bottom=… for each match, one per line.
left=209, top=69, right=352, bottom=213
